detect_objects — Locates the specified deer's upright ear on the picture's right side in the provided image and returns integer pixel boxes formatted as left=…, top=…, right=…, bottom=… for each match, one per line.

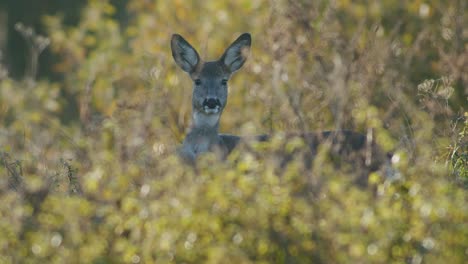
left=220, top=33, right=252, bottom=73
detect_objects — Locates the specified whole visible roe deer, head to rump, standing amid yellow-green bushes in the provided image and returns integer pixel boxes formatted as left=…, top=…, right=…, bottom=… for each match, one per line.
left=171, top=33, right=394, bottom=177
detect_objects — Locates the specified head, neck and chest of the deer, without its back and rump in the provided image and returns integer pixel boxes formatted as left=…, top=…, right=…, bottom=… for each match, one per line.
left=171, top=33, right=251, bottom=161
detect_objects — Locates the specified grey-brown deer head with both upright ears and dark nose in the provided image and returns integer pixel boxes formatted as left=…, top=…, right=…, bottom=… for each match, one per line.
left=171, top=33, right=251, bottom=127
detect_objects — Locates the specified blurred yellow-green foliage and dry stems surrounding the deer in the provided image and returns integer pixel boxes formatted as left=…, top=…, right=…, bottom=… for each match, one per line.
left=0, top=0, right=468, bottom=263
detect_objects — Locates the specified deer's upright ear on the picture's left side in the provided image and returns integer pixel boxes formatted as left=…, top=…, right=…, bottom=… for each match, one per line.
left=171, top=34, right=200, bottom=73
